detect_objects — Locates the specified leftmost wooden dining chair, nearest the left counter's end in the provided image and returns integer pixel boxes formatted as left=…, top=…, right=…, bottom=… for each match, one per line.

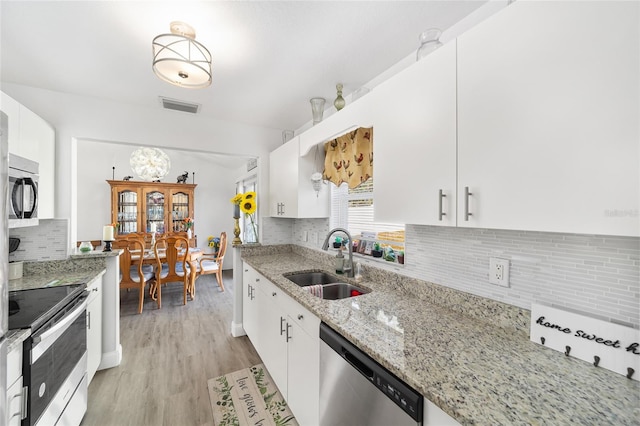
left=113, top=236, right=155, bottom=314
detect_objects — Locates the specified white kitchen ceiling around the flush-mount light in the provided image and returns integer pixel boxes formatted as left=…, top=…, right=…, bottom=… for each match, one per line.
left=0, top=0, right=484, bottom=133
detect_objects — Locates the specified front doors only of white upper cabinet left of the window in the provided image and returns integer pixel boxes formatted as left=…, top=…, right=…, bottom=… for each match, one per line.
left=269, top=137, right=299, bottom=217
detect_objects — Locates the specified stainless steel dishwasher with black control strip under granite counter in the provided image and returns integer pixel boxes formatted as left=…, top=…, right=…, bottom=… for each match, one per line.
left=320, top=323, right=423, bottom=426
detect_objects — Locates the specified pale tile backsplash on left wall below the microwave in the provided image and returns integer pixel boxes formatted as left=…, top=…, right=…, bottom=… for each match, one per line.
left=9, top=219, right=69, bottom=262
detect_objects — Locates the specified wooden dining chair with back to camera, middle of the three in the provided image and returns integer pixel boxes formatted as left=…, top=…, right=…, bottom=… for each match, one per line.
left=153, top=236, right=189, bottom=307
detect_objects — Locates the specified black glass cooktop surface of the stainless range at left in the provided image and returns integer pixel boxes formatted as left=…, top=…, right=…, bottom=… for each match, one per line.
left=9, top=284, right=86, bottom=330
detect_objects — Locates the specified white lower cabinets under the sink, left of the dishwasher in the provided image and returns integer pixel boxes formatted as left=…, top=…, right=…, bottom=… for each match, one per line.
left=242, top=264, right=320, bottom=425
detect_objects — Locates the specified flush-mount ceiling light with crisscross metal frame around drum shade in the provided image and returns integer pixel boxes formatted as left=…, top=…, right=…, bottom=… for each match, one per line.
left=152, top=21, right=211, bottom=89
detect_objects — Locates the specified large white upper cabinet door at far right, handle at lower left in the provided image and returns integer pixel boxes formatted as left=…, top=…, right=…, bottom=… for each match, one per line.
left=458, top=2, right=640, bottom=235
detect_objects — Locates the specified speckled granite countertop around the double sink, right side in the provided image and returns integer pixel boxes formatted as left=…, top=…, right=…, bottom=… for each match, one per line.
left=242, top=252, right=640, bottom=425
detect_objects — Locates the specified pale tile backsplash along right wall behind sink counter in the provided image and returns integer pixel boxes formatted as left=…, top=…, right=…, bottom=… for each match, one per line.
left=263, top=219, right=640, bottom=328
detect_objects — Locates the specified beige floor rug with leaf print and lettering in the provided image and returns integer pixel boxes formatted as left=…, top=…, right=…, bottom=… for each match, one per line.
left=207, top=364, right=298, bottom=426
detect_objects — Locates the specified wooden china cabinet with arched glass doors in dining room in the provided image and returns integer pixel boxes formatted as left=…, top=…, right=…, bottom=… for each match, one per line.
left=107, top=180, right=197, bottom=247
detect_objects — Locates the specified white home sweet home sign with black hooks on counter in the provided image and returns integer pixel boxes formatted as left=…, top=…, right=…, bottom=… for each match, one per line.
left=531, top=304, right=640, bottom=381
